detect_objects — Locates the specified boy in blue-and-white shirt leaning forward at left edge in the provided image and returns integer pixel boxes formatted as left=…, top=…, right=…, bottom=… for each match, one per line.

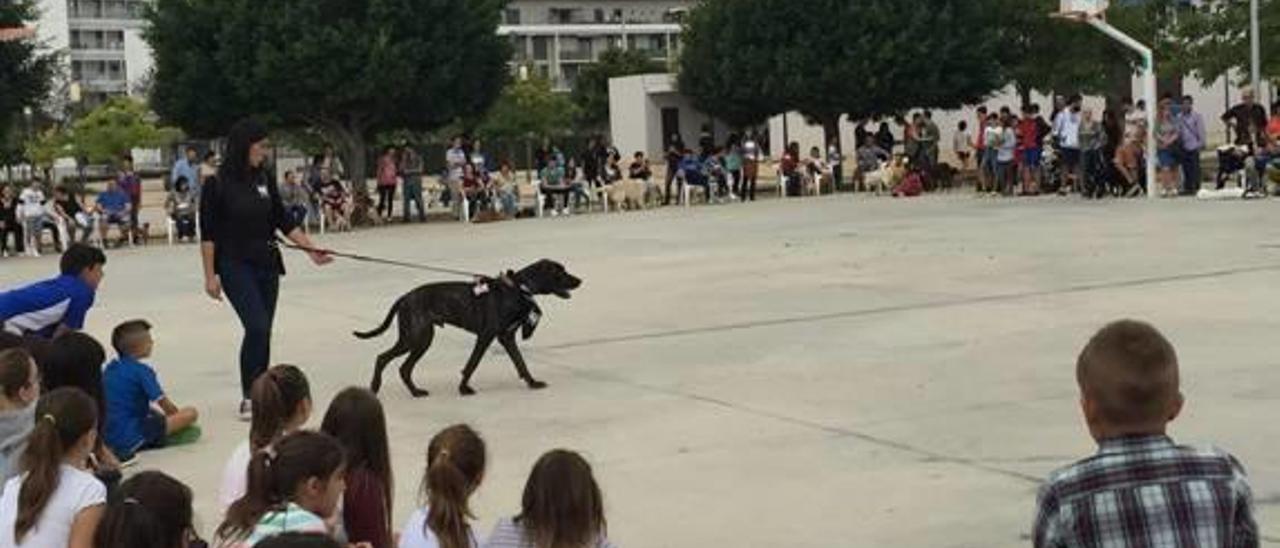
left=0, top=243, right=106, bottom=339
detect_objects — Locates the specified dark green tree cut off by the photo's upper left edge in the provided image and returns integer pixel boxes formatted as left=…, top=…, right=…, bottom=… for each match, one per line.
left=0, top=0, right=58, bottom=169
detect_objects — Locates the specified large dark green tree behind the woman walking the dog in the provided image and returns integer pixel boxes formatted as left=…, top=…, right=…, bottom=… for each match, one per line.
left=146, top=0, right=509, bottom=201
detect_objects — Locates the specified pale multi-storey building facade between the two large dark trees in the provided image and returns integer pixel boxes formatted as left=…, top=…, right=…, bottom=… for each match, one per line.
left=498, top=0, right=694, bottom=91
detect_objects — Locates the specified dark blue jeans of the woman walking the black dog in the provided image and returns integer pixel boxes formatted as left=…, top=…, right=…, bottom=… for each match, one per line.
left=218, top=259, right=280, bottom=399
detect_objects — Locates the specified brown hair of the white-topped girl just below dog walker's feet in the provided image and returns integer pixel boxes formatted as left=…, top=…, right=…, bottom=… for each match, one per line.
left=248, top=365, right=311, bottom=452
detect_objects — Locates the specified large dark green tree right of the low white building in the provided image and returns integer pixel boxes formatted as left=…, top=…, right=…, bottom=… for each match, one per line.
left=680, top=0, right=1004, bottom=153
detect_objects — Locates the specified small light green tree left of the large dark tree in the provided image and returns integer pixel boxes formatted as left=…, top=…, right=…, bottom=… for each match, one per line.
left=62, top=97, right=182, bottom=164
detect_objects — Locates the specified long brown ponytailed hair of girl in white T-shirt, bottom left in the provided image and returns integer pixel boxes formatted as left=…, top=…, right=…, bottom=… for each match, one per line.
left=13, top=388, right=97, bottom=544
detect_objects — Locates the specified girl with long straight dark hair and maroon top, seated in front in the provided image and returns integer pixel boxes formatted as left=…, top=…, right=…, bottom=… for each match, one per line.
left=320, top=388, right=393, bottom=548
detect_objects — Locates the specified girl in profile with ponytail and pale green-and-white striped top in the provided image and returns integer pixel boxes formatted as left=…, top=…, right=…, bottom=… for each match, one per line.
left=216, top=430, right=347, bottom=548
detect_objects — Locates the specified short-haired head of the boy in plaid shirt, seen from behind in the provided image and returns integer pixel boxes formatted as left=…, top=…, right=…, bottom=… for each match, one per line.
left=1075, top=320, right=1183, bottom=439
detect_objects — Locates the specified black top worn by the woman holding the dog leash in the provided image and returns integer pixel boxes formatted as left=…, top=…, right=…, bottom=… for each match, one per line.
left=200, top=170, right=297, bottom=274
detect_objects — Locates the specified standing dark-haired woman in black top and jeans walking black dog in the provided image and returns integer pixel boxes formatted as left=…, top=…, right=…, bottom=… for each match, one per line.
left=200, top=119, right=333, bottom=420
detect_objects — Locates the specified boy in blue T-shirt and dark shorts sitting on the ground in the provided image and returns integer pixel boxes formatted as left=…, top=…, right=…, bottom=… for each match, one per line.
left=102, top=320, right=200, bottom=462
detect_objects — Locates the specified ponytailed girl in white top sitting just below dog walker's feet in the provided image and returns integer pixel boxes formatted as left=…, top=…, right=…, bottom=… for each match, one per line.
left=218, top=365, right=311, bottom=510
